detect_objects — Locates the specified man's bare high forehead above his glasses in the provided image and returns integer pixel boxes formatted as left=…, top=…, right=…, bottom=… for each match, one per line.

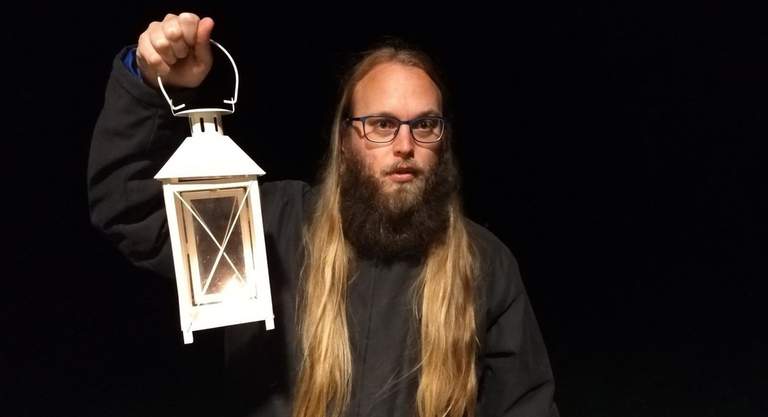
left=351, top=63, right=442, bottom=114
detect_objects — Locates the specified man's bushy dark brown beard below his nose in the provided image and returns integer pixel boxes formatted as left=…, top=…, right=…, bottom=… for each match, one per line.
left=341, top=150, right=458, bottom=261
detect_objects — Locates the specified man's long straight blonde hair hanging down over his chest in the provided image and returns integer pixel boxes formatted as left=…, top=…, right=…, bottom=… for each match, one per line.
left=293, top=46, right=477, bottom=417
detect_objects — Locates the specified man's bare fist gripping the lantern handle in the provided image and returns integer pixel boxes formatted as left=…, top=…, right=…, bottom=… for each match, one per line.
left=136, top=13, right=213, bottom=87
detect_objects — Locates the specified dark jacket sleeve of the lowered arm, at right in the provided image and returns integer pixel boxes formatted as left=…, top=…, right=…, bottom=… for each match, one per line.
left=478, top=241, right=559, bottom=417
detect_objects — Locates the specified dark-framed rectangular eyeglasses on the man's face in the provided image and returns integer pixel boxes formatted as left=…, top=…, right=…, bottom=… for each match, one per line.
left=347, top=116, right=445, bottom=143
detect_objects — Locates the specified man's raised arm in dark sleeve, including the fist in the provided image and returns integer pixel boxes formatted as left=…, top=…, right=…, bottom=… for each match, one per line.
left=88, top=13, right=218, bottom=277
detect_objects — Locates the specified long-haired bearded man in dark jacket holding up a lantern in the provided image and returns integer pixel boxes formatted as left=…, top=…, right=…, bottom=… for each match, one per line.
left=89, top=13, right=557, bottom=417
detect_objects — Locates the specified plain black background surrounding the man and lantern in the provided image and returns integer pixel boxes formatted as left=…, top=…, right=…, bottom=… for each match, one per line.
left=0, top=2, right=768, bottom=416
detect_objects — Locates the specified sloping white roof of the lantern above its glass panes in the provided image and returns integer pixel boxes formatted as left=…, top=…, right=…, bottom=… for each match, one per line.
left=155, top=133, right=265, bottom=181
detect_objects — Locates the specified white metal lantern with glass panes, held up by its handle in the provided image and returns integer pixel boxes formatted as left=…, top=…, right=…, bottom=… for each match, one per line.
left=155, top=41, right=275, bottom=343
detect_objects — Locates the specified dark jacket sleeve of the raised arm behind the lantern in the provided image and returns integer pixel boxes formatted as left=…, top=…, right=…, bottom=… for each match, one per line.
left=87, top=48, right=188, bottom=277
